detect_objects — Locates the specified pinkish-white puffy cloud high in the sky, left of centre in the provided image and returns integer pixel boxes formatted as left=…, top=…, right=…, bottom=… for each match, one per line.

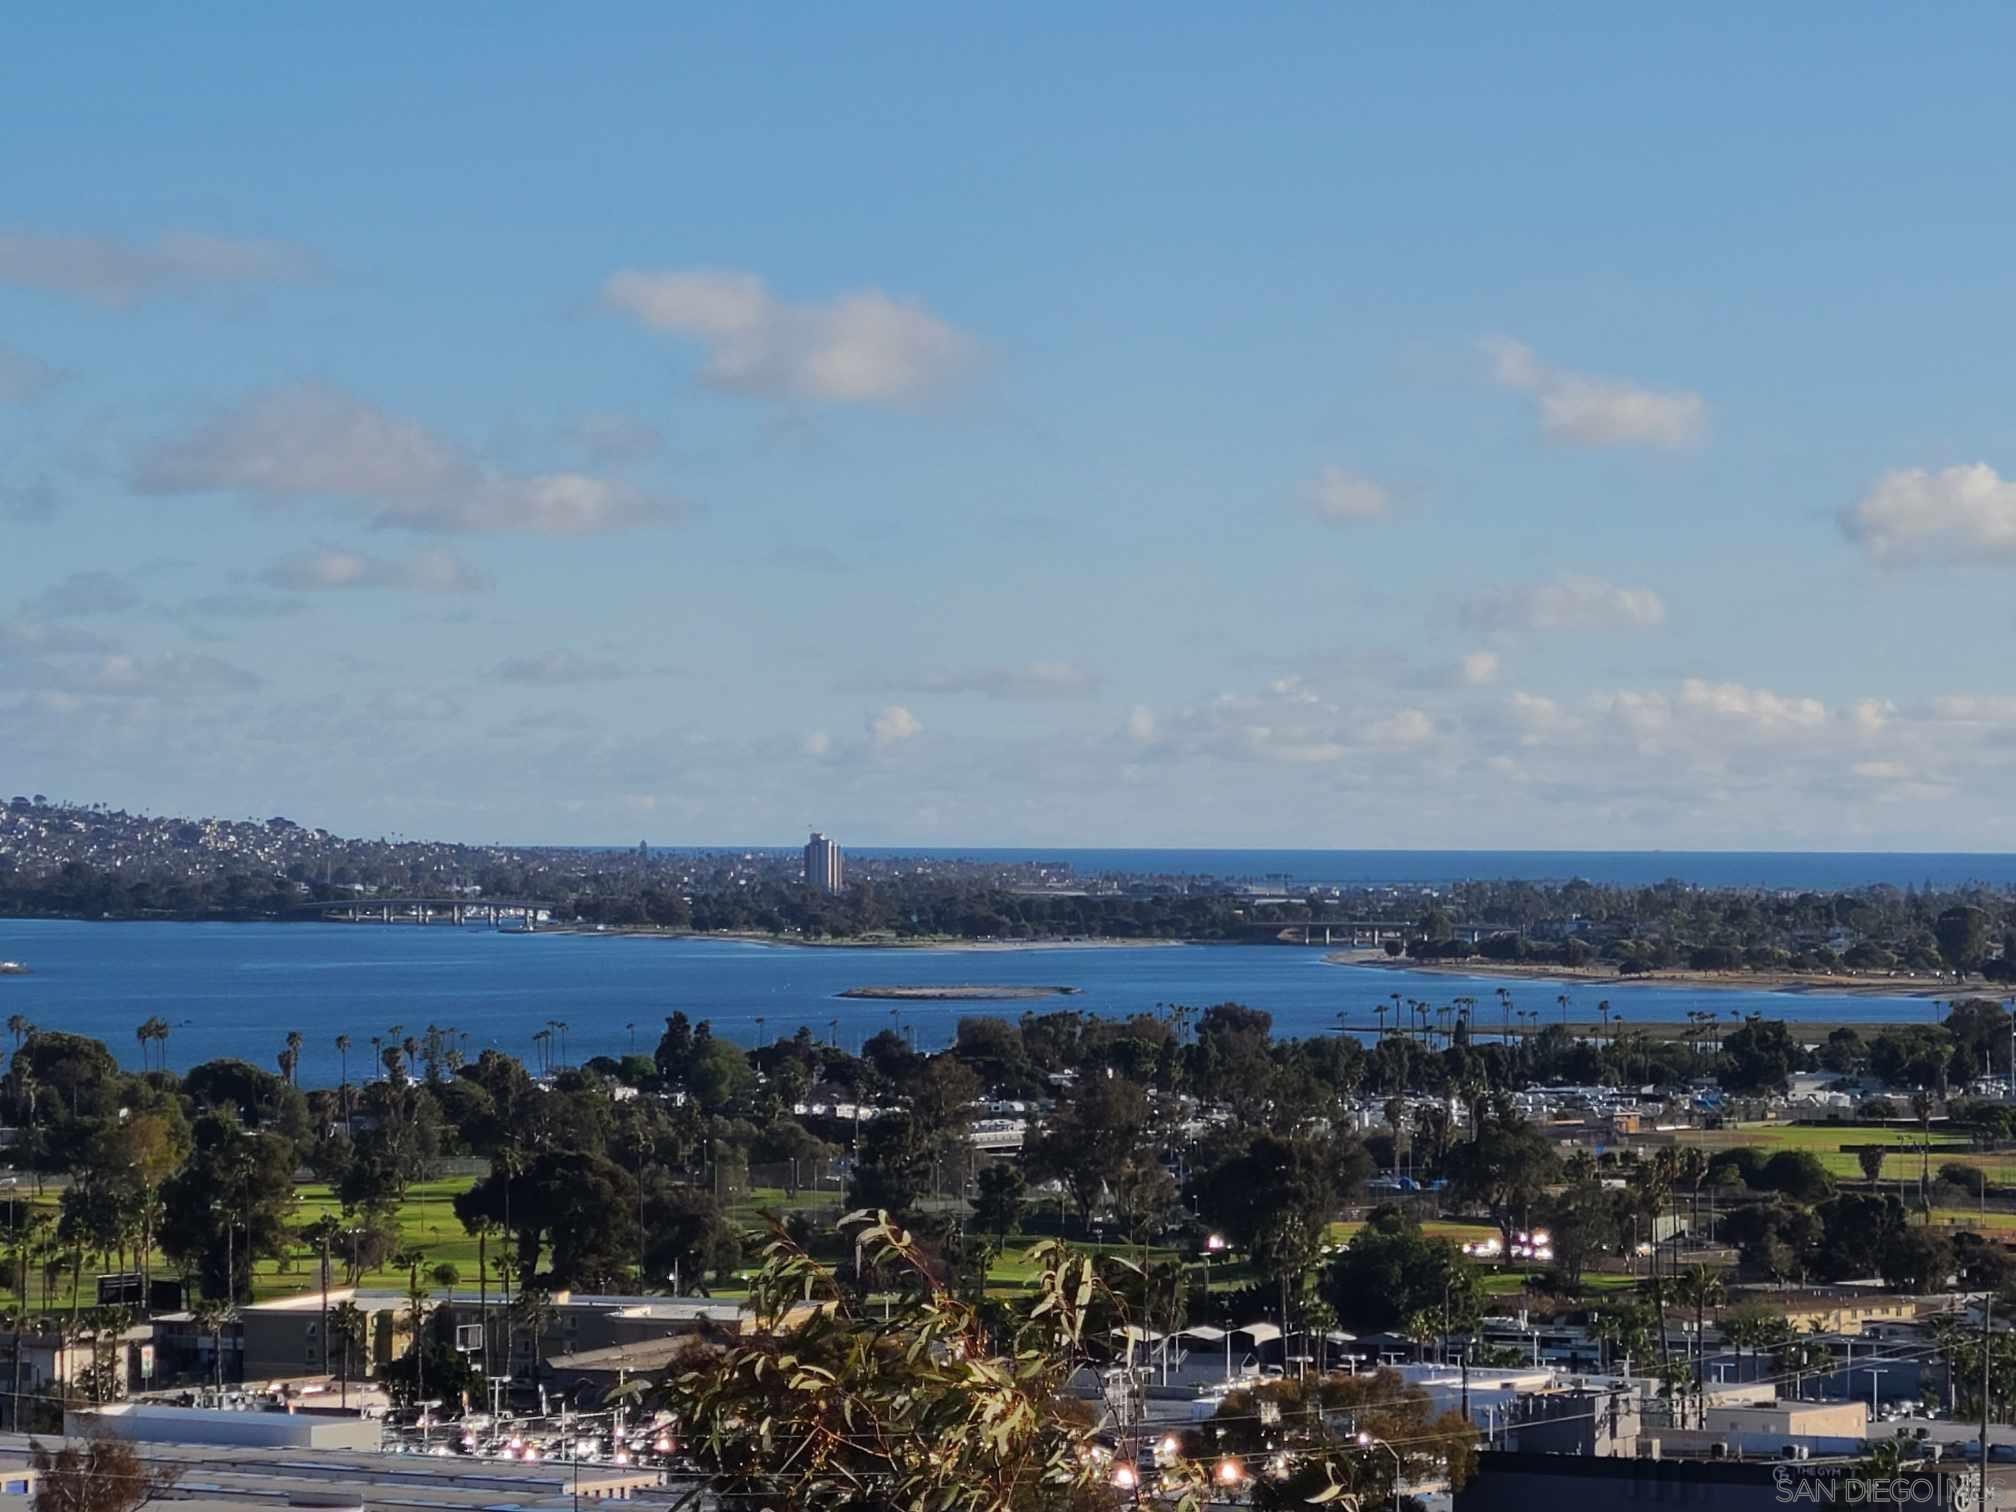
left=603, top=268, right=974, bottom=403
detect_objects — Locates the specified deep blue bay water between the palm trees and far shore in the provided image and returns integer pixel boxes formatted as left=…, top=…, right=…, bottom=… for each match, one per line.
left=0, top=919, right=1937, bottom=1087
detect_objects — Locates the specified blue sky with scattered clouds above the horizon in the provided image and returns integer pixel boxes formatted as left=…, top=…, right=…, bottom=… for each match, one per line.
left=0, top=4, right=2016, bottom=849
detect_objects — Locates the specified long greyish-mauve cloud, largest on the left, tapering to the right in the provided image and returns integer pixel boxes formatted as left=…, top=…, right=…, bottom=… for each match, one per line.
left=133, top=385, right=677, bottom=534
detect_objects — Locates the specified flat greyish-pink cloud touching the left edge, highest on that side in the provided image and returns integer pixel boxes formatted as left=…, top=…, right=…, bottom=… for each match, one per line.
left=0, top=232, right=314, bottom=304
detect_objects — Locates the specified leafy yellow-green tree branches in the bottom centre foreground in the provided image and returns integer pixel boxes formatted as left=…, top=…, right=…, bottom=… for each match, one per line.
left=663, top=1212, right=1200, bottom=1512
